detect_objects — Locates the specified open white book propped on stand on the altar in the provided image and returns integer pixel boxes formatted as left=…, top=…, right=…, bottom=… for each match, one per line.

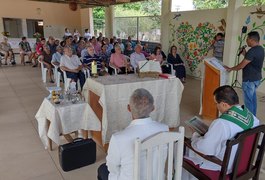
left=138, top=60, right=162, bottom=73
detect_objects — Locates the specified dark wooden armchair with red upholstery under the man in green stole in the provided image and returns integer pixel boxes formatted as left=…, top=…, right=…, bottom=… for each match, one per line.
left=183, top=125, right=265, bottom=180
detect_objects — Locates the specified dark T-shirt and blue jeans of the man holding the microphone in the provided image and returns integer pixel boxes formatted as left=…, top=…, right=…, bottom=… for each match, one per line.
left=242, top=45, right=264, bottom=115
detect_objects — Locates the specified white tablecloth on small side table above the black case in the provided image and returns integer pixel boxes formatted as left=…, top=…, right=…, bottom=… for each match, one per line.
left=35, top=98, right=101, bottom=148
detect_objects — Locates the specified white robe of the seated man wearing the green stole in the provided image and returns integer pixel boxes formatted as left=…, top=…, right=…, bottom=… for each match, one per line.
left=185, top=105, right=259, bottom=179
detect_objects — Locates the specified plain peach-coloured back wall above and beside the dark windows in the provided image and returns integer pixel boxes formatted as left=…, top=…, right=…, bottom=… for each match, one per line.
left=0, top=0, right=83, bottom=38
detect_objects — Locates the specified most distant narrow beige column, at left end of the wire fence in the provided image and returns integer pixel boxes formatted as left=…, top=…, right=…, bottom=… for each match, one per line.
left=105, top=6, right=114, bottom=38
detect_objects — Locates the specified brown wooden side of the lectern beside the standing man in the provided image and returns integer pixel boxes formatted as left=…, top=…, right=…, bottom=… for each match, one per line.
left=201, top=61, right=220, bottom=120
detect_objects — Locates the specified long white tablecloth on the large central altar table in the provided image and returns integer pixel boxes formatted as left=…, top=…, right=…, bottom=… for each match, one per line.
left=83, top=74, right=183, bottom=144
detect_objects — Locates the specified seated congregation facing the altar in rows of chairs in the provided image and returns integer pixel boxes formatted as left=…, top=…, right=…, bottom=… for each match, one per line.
left=0, top=28, right=186, bottom=87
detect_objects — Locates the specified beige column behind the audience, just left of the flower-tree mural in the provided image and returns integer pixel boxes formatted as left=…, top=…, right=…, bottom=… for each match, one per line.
left=160, top=0, right=171, bottom=52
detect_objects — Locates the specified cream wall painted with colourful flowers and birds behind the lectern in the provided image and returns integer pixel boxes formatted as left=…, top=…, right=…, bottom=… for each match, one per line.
left=166, top=6, right=265, bottom=93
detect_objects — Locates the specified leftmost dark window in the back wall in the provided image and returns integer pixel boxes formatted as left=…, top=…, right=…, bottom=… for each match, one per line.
left=3, top=18, right=23, bottom=38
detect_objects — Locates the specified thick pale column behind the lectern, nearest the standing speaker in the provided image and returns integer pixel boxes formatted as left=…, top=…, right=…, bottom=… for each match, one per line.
left=223, top=0, right=243, bottom=84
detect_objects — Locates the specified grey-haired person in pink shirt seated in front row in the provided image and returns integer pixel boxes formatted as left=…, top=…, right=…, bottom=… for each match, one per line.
left=110, top=45, right=133, bottom=74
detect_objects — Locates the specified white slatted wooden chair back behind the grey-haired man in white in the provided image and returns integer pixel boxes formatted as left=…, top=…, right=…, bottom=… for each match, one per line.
left=134, top=127, right=184, bottom=180
